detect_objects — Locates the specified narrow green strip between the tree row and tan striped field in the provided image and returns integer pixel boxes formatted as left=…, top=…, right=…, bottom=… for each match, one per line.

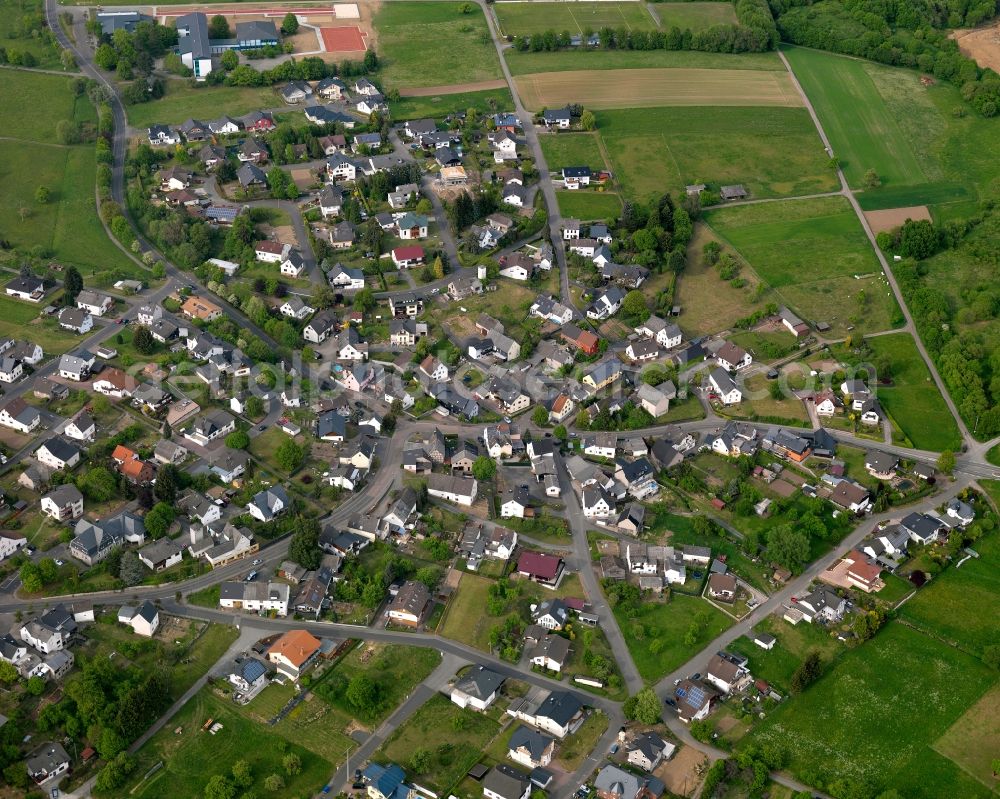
left=504, top=47, right=785, bottom=75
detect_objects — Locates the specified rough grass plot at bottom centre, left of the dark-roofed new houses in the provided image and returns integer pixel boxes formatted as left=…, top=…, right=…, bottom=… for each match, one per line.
left=374, top=694, right=500, bottom=796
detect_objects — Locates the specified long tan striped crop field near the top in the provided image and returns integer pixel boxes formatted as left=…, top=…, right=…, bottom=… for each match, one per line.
left=515, top=69, right=802, bottom=111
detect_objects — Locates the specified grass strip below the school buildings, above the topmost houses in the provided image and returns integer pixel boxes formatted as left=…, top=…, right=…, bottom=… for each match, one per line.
left=126, top=80, right=281, bottom=130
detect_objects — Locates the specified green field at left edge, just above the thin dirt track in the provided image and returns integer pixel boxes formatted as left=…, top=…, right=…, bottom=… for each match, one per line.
left=0, top=70, right=97, bottom=144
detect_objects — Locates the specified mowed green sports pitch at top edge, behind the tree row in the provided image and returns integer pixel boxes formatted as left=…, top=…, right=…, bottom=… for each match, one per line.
left=493, top=0, right=656, bottom=36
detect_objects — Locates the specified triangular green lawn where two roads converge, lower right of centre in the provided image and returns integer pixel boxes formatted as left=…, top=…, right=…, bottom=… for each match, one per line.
left=614, top=593, right=733, bottom=682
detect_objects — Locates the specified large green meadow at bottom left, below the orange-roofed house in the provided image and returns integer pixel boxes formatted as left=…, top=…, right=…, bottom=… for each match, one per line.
left=119, top=687, right=333, bottom=799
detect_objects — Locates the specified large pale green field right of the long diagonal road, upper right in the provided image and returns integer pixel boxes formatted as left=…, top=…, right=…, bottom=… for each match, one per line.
left=785, top=47, right=1000, bottom=210
